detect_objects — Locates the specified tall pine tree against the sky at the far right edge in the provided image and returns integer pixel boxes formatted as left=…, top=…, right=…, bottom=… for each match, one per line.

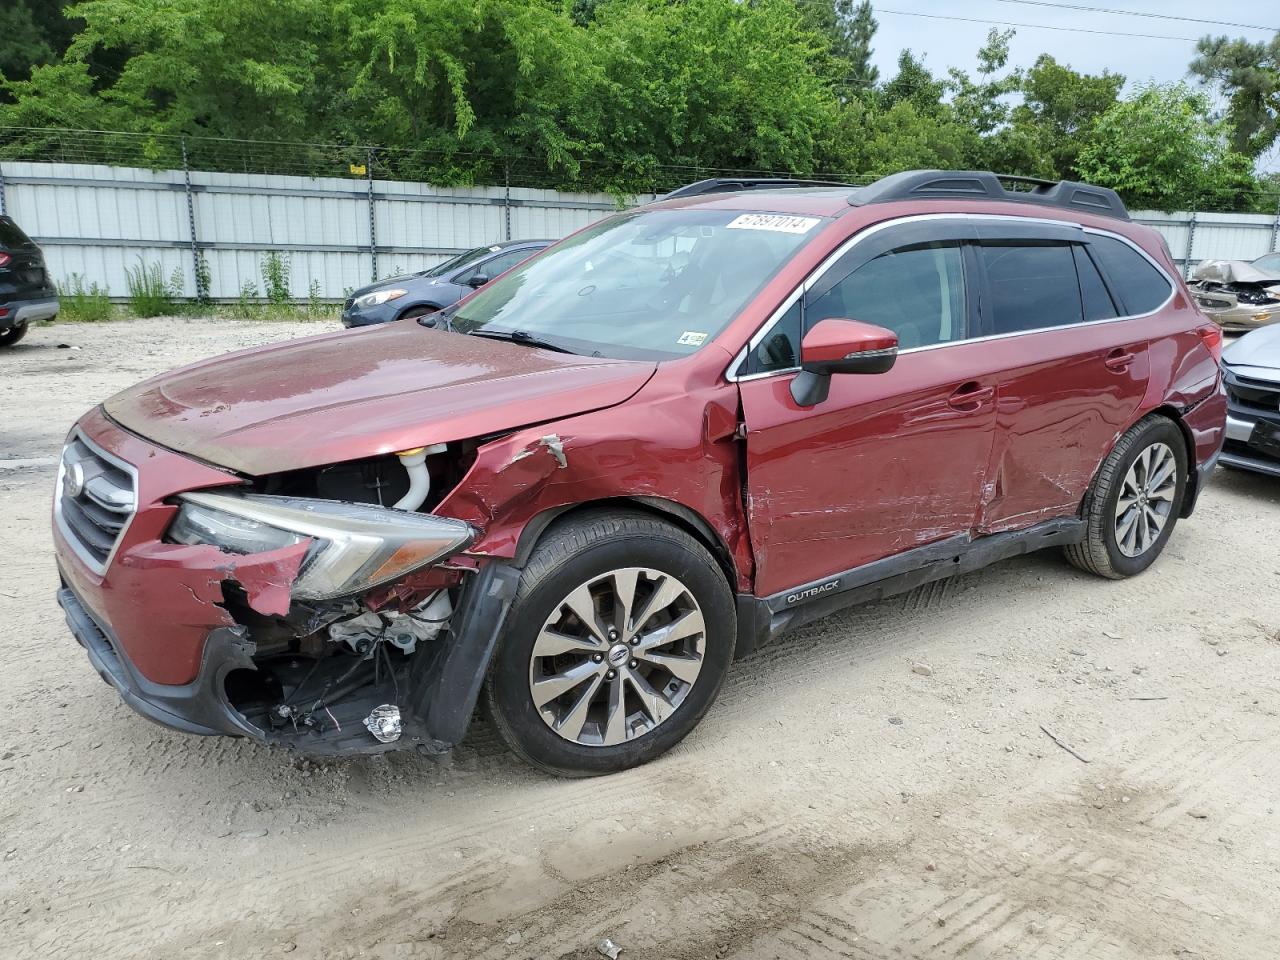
left=1189, top=33, right=1280, bottom=157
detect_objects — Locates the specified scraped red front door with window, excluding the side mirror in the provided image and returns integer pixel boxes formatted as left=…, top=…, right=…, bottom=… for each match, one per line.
left=739, top=221, right=998, bottom=596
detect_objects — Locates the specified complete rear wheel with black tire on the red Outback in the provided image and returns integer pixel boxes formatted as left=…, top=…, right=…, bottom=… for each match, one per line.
left=1064, top=415, right=1187, bottom=580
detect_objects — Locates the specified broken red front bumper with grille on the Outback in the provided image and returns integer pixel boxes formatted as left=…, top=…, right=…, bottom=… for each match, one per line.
left=54, top=411, right=520, bottom=755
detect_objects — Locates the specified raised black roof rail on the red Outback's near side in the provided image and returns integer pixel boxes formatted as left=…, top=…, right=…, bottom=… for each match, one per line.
left=849, top=170, right=1129, bottom=220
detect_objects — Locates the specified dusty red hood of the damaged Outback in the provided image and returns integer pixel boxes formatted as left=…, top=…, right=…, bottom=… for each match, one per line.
left=104, top=321, right=655, bottom=476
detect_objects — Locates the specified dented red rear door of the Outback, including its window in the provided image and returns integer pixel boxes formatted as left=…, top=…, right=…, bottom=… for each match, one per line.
left=977, top=221, right=1151, bottom=532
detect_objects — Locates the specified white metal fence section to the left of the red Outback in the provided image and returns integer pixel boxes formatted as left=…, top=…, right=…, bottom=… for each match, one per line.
left=0, top=161, right=634, bottom=300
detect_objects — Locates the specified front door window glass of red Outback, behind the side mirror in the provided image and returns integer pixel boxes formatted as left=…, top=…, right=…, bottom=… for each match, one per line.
left=804, top=243, right=966, bottom=349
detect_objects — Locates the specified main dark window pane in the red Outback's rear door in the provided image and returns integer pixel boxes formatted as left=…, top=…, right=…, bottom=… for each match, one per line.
left=978, top=241, right=1084, bottom=334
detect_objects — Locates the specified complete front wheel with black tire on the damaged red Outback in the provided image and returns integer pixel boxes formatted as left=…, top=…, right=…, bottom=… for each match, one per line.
left=485, top=511, right=736, bottom=777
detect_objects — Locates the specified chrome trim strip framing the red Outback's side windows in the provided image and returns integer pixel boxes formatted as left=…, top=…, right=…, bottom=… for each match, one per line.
left=724, top=214, right=1178, bottom=383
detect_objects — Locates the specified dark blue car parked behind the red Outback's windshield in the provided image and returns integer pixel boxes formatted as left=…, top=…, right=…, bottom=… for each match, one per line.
left=342, top=241, right=554, bottom=326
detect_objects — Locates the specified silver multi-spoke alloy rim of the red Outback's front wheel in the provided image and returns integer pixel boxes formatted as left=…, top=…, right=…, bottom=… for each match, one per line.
left=529, top=567, right=707, bottom=746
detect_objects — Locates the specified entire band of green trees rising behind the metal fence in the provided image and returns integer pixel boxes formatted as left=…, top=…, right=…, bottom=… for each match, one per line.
left=0, top=0, right=1280, bottom=209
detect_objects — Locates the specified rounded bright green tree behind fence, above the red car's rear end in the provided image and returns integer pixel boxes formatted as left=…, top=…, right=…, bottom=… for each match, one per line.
left=1076, top=83, right=1253, bottom=210
